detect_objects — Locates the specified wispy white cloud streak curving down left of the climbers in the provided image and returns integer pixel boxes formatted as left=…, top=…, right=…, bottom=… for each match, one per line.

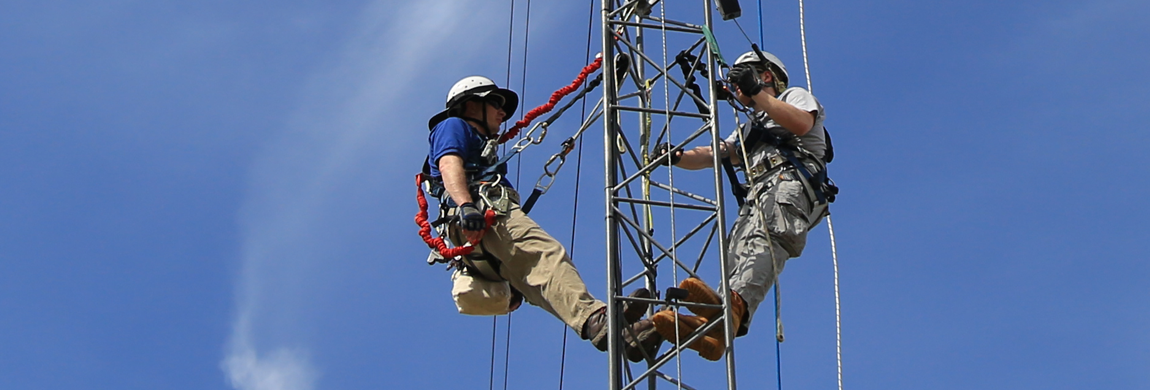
left=221, top=0, right=499, bottom=390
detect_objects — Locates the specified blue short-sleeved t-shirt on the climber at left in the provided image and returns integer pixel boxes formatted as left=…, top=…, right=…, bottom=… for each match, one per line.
left=428, top=117, right=511, bottom=186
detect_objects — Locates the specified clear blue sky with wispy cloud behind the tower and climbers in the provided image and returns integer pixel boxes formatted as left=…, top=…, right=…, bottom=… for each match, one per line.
left=0, top=0, right=1150, bottom=390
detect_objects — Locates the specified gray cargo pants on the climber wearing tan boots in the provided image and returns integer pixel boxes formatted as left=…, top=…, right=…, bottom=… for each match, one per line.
left=727, top=169, right=819, bottom=336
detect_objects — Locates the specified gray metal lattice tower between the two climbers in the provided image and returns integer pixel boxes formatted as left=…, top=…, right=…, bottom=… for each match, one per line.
left=601, top=0, right=735, bottom=389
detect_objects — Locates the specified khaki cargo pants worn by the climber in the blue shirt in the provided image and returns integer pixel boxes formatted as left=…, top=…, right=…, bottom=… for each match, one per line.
left=450, top=189, right=607, bottom=336
